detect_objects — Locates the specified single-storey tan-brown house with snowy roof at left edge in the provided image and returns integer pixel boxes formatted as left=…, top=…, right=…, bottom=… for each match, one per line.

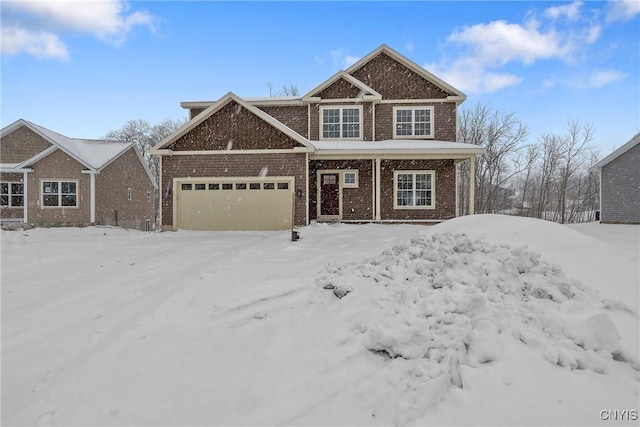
left=0, top=119, right=157, bottom=230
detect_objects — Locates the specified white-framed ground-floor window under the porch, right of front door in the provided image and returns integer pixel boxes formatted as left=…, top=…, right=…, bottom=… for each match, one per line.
left=394, top=171, right=435, bottom=209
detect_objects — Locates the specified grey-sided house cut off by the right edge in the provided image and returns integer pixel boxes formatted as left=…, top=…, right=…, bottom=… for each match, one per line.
left=591, top=133, right=640, bottom=224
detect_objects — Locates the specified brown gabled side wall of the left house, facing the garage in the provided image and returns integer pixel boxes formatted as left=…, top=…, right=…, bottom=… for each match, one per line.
left=96, top=147, right=155, bottom=231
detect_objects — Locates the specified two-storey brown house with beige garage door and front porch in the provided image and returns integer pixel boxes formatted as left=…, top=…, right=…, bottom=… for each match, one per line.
left=152, top=45, right=483, bottom=230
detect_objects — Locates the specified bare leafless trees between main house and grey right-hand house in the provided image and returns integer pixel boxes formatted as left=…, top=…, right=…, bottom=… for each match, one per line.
left=458, top=104, right=600, bottom=224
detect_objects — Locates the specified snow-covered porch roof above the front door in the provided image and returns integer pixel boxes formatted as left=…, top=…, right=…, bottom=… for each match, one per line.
left=309, top=139, right=484, bottom=154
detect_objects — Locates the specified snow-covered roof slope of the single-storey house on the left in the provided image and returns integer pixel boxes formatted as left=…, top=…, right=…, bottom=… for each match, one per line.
left=25, top=120, right=133, bottom=169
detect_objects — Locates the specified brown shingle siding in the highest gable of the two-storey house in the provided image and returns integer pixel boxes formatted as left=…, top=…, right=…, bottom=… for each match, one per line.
left=351, top=53, right=452, bottom=99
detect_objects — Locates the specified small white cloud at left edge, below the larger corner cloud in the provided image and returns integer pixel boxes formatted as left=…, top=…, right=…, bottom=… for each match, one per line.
left=0, top=26, right=69, bottom=61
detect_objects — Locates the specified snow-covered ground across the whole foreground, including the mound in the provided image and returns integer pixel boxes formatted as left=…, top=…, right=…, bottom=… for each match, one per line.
left=1, top=215, right=640, bottom=426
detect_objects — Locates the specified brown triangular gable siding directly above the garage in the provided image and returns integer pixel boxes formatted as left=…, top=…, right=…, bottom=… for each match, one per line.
left=168, top=101, right=306, bottom=151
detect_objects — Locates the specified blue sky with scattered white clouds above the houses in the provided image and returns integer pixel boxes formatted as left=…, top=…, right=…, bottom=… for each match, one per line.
left=1, top=0, right=640, bottom=155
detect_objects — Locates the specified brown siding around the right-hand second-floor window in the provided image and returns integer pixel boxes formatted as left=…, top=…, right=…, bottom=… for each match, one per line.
left=376, top=102, right=456, bottom=142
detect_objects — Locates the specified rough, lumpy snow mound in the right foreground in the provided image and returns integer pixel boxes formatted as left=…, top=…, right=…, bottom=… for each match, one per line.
left=317, top=233, right=620, bottom=394
